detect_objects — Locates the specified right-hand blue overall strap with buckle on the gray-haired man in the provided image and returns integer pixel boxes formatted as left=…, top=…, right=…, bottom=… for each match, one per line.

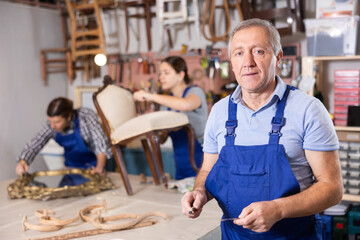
left=269, top=85, right=295, bottom=144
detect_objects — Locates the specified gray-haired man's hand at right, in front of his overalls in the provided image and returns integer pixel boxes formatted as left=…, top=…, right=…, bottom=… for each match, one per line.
left=234, top=201, right=281, bottom=232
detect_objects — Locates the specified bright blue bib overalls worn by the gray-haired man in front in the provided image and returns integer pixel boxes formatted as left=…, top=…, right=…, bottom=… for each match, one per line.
left=205, top=86, right=321, bottom=240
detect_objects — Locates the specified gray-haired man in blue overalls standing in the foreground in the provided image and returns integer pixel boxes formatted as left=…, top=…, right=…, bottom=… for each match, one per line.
left=182, top=19, right=343, bottom=240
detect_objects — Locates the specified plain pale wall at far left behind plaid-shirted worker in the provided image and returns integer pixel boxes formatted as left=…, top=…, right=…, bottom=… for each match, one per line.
left=0, top=2, right=67, bottom=180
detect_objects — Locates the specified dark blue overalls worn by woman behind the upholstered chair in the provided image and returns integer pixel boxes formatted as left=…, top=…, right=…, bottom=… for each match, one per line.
left=168, top=87, right=203, bottom=179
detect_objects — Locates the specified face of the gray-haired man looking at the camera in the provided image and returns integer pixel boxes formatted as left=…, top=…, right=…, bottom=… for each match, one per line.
left=230, top=27, right=282, bottom=93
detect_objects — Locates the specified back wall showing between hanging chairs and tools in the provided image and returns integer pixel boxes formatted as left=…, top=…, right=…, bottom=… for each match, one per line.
left=68, top=0, right=315, bottom=105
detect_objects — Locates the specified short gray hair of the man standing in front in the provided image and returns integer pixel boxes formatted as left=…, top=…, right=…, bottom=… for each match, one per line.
left=228, top=18, right=281, bottom=58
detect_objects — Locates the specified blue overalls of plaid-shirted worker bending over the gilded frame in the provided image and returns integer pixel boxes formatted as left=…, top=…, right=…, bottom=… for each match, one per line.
left=55, top=113, right=97, bottom=186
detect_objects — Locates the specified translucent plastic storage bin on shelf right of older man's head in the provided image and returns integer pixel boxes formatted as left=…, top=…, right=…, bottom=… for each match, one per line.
left=304, top=16, right=359, bottom=56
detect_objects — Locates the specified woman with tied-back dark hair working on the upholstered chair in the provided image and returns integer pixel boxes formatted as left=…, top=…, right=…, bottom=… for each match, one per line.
left=134, top=56, right=208, bottom=179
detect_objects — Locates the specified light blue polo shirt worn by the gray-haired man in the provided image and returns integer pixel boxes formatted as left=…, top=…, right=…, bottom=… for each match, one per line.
left=203, top=76, right=339, bottom=190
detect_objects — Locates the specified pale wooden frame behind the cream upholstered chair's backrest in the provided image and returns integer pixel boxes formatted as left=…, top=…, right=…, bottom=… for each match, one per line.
left=74, top=86, right=100, bottom=112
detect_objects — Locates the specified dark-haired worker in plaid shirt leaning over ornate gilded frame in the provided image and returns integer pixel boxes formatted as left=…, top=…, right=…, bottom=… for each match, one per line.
left=15, top=97, right=113, bottom=180
